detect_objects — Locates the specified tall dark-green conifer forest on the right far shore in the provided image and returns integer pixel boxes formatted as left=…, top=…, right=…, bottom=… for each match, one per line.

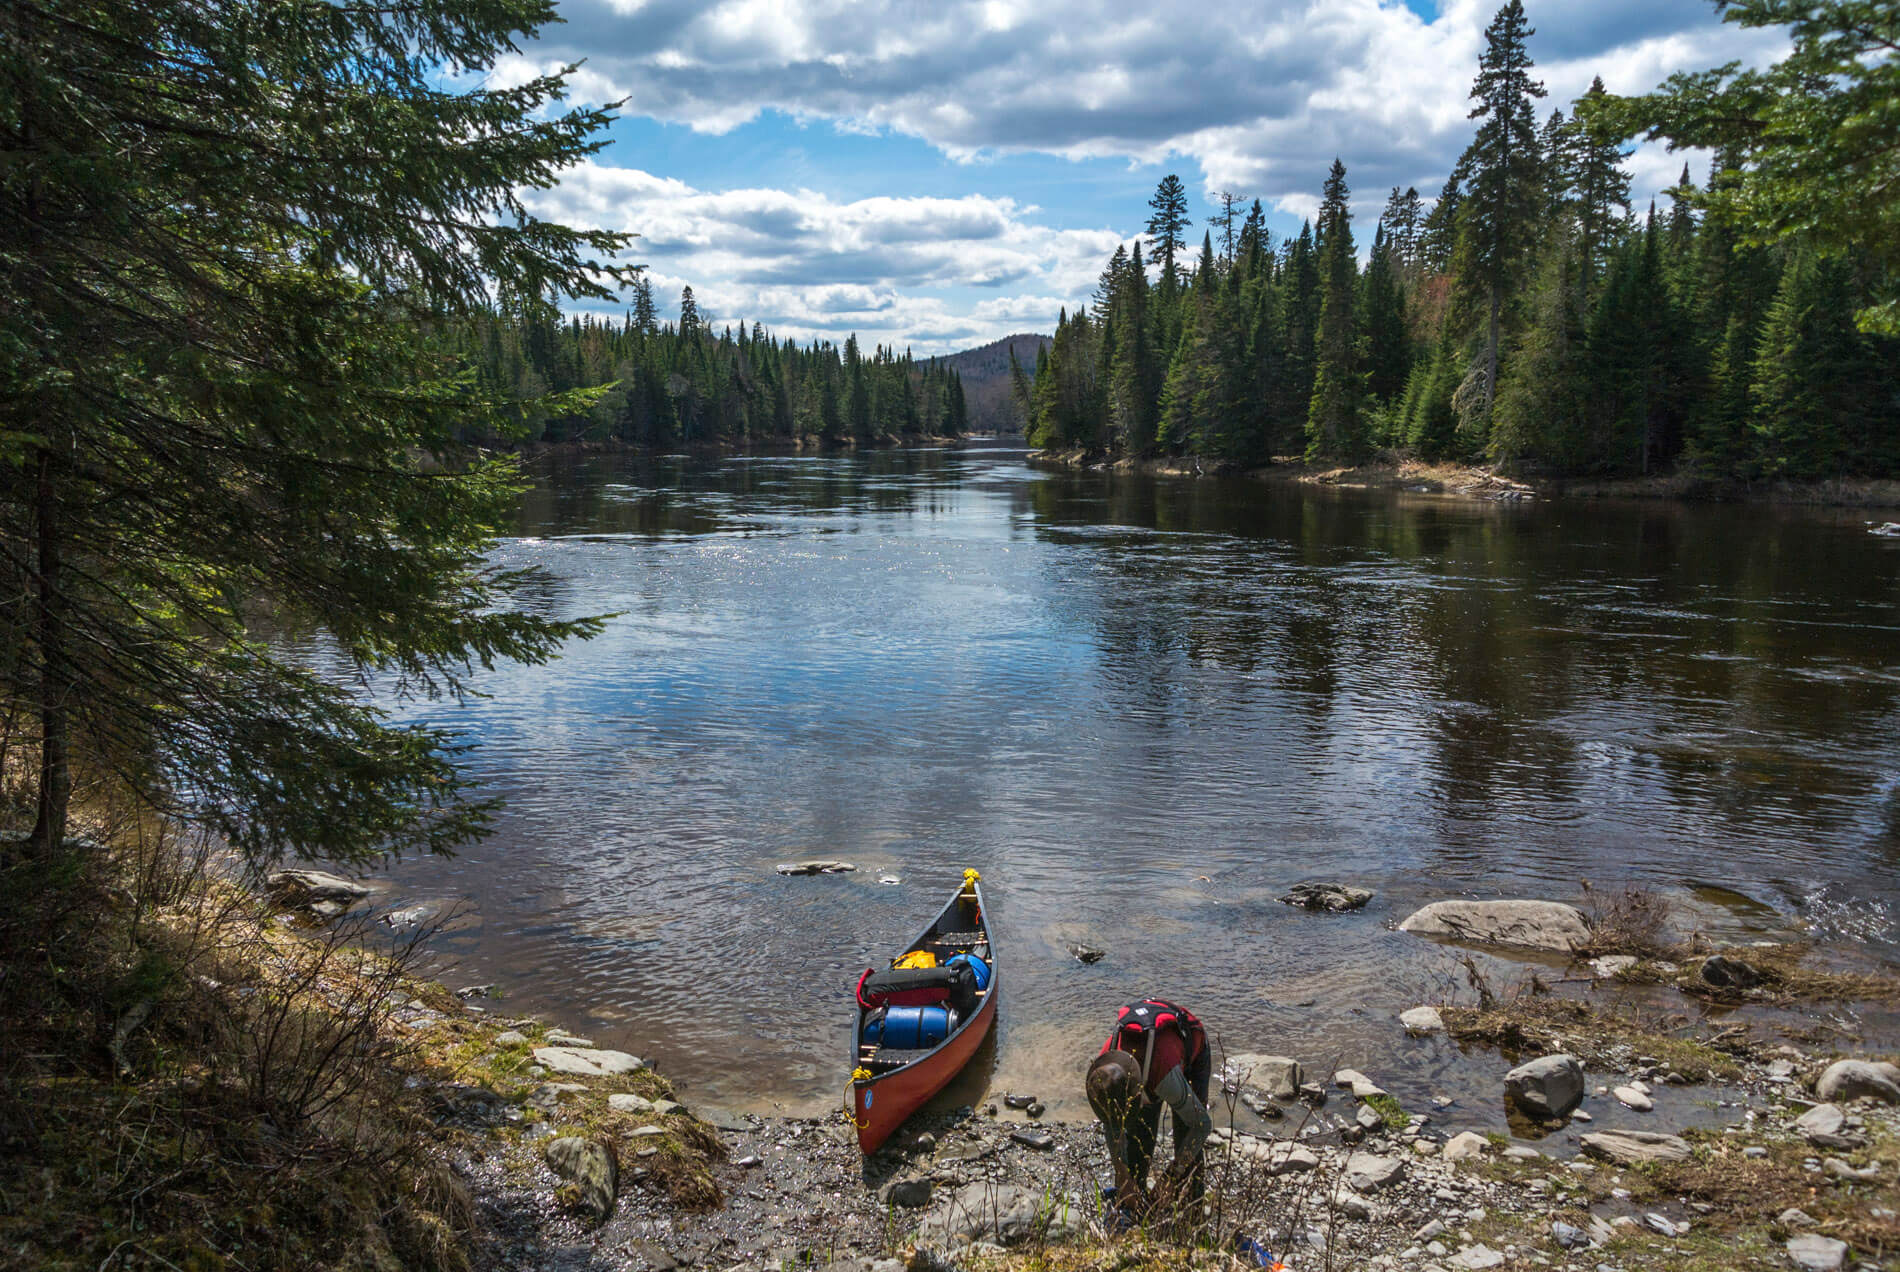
left=1018, top=0, right=1900, bottom=481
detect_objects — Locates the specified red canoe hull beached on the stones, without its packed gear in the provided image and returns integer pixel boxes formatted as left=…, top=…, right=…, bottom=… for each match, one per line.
left=849, top=871, right=999, bottom=1154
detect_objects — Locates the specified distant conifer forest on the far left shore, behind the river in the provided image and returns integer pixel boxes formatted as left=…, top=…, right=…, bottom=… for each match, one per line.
left=456, top=276, right=969, bottom=451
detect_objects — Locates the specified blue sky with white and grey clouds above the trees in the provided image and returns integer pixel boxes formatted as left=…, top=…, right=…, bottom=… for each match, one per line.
left=492, top=0, right=1778, bottom=354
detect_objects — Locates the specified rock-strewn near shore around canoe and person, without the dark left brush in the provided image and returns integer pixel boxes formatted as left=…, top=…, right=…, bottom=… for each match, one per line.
left=260, top=873, right=1900, bottom=1272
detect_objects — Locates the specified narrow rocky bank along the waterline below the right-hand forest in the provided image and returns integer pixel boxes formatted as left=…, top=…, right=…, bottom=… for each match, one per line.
left=1028, top=451, right=1900, bottom=508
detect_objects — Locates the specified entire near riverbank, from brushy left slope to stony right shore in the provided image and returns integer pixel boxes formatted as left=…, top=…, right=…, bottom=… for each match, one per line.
left=11, top=832, right=1900, bottom=1272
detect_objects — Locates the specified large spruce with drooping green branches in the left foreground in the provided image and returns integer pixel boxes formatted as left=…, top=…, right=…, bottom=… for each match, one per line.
left=0, top=0, right=633, bottom=861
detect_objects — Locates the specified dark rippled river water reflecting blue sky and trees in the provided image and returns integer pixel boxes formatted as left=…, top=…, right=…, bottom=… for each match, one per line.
left=374, top=447, right=1900, bottom=1133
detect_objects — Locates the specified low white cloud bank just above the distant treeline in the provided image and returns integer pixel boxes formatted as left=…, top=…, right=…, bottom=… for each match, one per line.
left=524, top=162, right=1119, bottom=354
